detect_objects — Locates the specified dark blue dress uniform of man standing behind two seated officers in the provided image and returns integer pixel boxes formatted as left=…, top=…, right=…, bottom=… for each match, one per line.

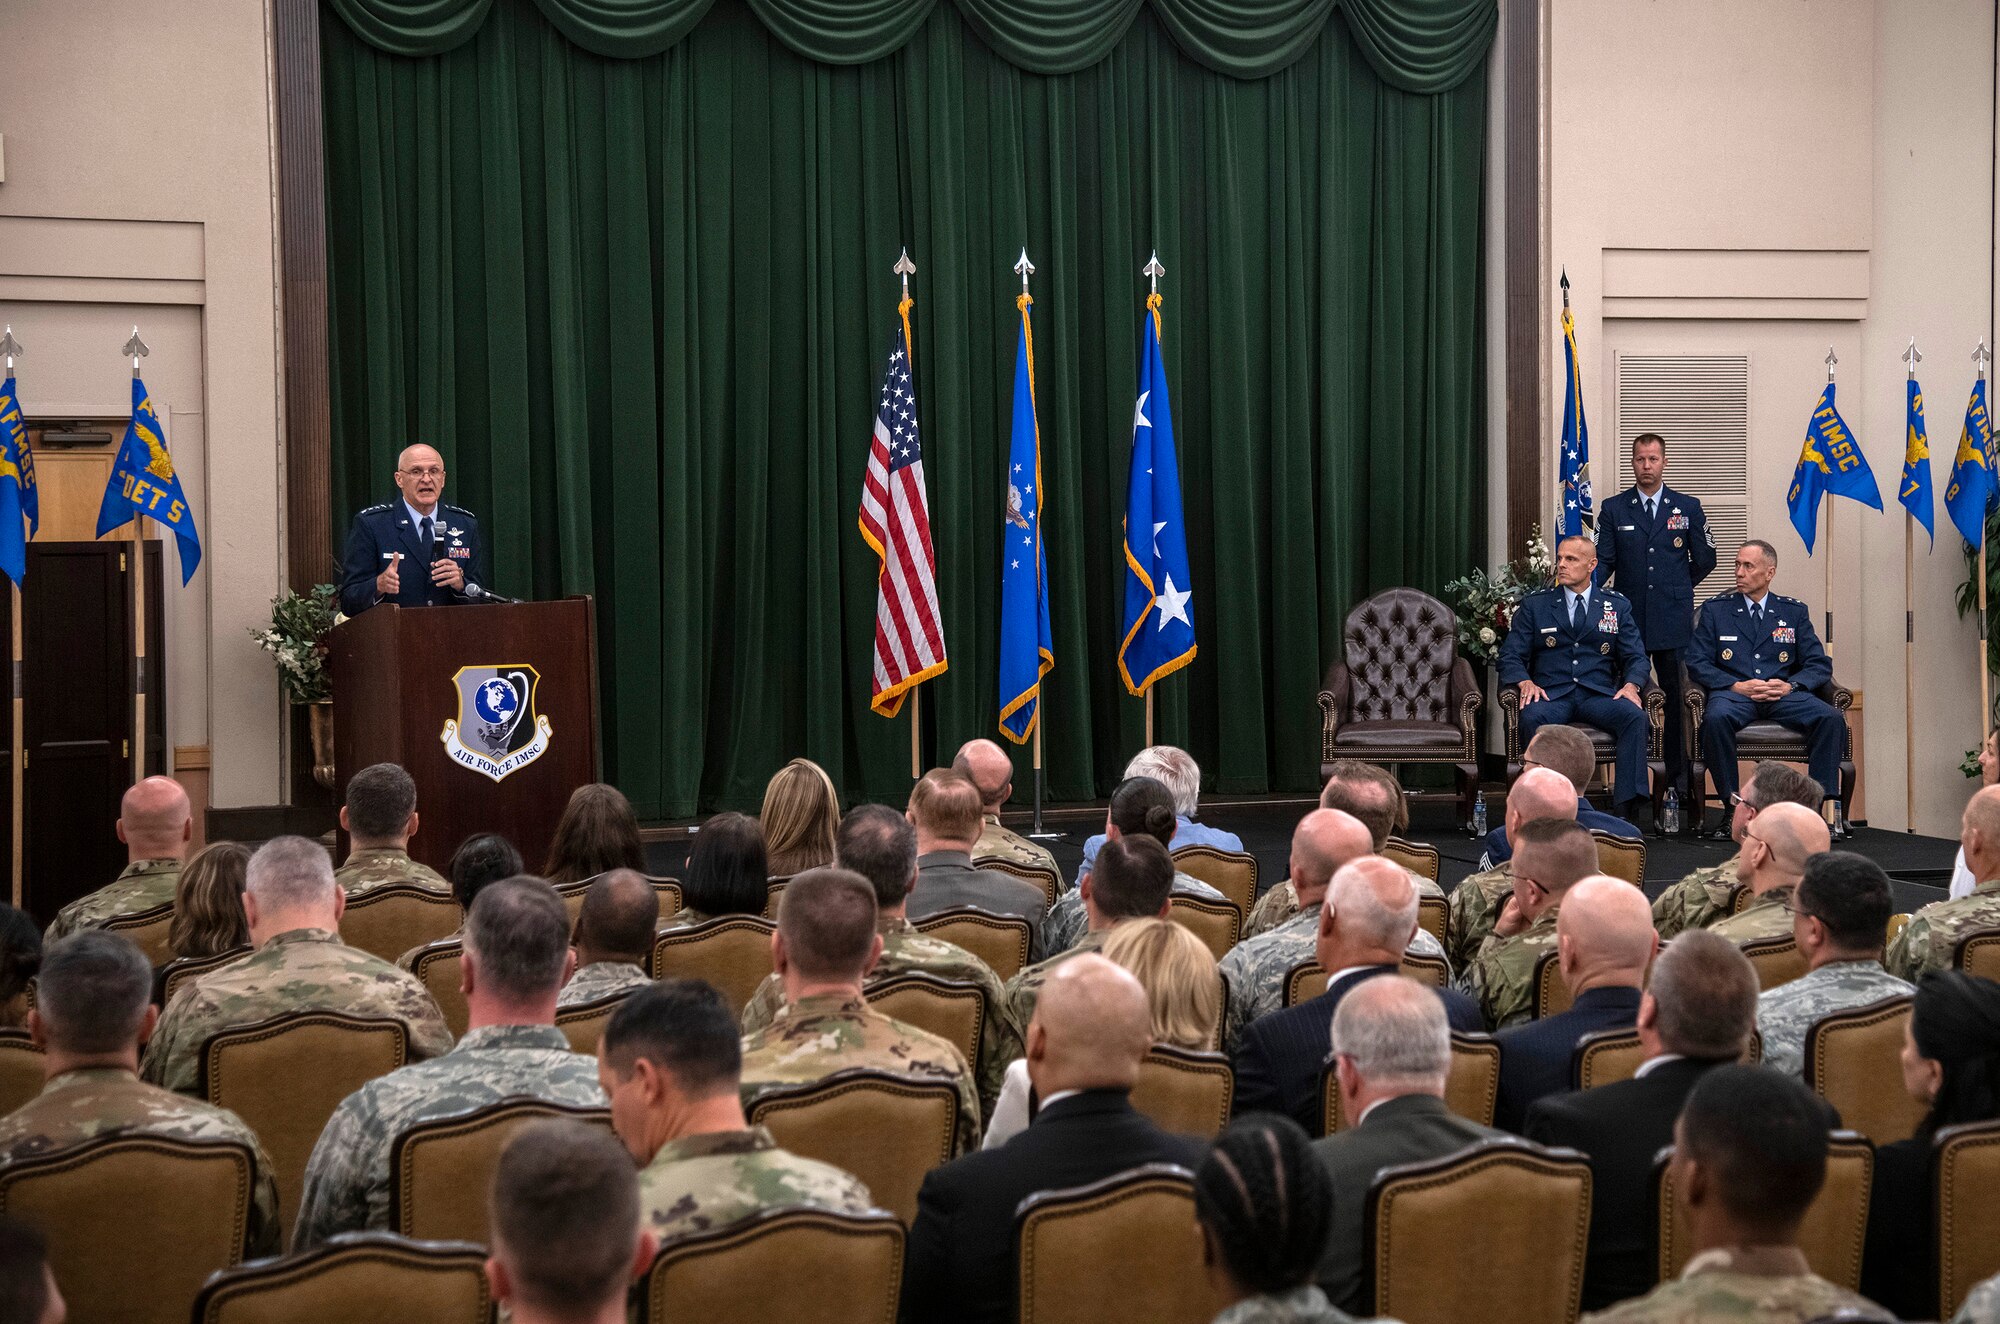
left=1598, top=484, right=1716, bottom=792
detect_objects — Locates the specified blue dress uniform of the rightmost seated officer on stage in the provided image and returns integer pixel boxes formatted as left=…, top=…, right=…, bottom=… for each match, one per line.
left=1688, top=592, right=1848, bottom=804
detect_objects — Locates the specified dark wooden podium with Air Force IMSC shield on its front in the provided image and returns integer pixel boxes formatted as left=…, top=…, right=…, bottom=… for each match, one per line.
left=328, top=598, right=598, bottom=874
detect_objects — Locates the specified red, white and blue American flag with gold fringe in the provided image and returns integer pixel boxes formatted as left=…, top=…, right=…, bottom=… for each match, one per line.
left=862, top=316, right=946, bottom=718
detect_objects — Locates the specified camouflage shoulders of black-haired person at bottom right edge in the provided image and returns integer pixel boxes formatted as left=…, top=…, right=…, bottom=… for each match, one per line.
left=1584, top=1246, right=1896, bottom=1324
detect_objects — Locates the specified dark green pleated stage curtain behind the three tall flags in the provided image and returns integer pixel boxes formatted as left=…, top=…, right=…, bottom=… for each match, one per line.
left=322, top=0, right=1490, bottom=818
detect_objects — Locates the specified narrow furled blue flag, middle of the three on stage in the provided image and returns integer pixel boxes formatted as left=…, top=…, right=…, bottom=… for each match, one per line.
left=1000, top=292, right=1056, bottom=744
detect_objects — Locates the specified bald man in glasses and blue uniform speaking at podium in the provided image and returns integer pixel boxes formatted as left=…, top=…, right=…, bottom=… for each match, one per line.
left=340, top=446, right=486, bottom=616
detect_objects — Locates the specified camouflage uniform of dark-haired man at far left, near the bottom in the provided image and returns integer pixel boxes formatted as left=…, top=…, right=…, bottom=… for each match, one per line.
left=0, top=1066, right=284, bottom=1260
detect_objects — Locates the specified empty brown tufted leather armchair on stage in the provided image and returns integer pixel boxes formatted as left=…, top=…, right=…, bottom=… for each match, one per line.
left=1320, top=588, right=1480, bottom=822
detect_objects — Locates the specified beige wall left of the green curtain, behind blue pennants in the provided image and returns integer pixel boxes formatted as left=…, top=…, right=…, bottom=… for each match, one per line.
left=0, top=0, right=284, bottom=806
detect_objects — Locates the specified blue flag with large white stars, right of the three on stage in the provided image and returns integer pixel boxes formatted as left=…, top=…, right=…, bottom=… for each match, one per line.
left=1118, top=294, right=1194, bottom=694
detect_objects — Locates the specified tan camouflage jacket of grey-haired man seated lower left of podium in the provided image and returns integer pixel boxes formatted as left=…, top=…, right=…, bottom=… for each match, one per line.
left=142, top=928, right=452, bottom=1094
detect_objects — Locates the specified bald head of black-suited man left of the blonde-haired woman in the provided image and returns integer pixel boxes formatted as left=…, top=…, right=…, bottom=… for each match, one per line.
left=1028, top=952, right=1152, bottom=1098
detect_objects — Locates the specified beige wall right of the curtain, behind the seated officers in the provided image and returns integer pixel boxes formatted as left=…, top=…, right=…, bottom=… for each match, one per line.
left=1544, top=0, right=1994, bottom=836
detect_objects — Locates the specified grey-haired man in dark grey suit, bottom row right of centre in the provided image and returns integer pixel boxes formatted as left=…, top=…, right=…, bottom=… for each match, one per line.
left=1312, top=980, right=1502, bottom=1316
